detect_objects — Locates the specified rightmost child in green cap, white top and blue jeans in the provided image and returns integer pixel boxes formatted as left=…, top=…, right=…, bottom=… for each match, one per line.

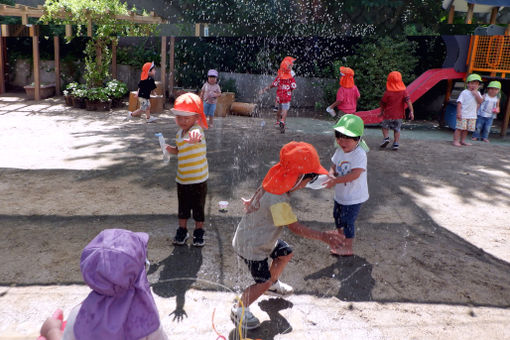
left=471, top=80, right=501, bottom=143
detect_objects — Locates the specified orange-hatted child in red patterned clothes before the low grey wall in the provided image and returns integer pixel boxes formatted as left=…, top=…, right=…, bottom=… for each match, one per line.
left=260, top=56, right=296, bottom=133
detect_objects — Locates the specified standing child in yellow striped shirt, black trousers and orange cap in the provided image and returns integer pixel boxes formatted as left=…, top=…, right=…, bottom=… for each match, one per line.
left=166, top=93, right=209, bottom=247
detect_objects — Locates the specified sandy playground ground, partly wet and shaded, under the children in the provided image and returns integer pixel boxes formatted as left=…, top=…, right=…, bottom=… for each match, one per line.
left=0, top=96, right=510, bottom=340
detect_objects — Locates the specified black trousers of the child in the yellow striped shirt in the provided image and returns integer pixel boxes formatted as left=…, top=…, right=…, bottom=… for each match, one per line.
left=177, top=181, right=207, bottom=222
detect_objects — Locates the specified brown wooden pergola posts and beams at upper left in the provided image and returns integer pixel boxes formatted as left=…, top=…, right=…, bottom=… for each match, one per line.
left=0, top=4, right=175, bottom=100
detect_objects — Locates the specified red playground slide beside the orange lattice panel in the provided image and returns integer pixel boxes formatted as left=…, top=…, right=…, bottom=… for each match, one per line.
left=356, top=68, right=466, bottom=125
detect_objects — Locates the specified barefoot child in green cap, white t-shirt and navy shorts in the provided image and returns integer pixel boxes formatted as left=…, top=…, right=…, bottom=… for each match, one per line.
left=325, top=114, right=368, bottom=256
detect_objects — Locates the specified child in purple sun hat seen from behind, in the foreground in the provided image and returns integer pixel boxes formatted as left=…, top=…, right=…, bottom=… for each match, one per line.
left=38, top=229, right=168, bottom=340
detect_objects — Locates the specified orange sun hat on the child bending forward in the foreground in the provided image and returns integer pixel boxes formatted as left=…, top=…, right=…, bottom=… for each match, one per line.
left=262, top=141, right=328, bottom=195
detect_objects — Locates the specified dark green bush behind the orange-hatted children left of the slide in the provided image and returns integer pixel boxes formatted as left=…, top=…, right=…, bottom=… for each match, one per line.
left=325, top=37, right=418, bottom=111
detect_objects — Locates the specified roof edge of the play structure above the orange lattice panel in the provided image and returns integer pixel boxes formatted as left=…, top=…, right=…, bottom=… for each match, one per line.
left=443, top=0, right=510, bottom=24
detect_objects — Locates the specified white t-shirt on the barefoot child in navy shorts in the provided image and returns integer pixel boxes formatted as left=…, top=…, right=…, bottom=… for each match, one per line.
left=331, top=145, right=368, bottom=205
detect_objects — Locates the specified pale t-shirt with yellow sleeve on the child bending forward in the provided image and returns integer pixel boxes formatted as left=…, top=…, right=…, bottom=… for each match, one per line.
left=232, top=192, right=297, bottom=261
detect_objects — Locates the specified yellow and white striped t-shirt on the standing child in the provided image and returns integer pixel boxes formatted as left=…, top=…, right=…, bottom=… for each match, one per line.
left=175, top=125, right=209, bottom=184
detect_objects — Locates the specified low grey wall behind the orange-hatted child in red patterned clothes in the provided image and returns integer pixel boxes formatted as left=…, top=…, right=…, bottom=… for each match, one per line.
left=220, top=72, right=336, bottom=107
